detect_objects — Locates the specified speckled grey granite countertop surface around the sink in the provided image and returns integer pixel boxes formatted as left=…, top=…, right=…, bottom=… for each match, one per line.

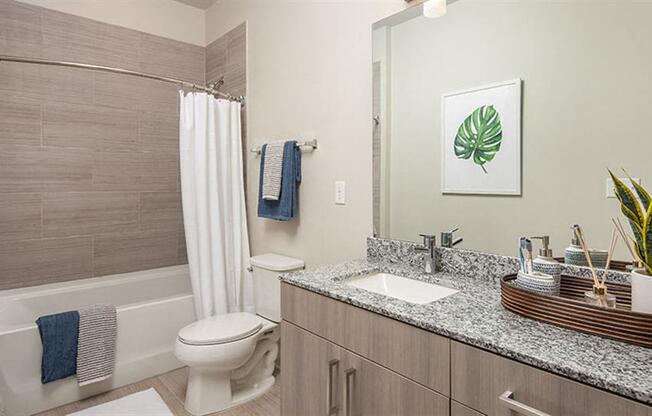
left=281, top=260, right=652, bottom=404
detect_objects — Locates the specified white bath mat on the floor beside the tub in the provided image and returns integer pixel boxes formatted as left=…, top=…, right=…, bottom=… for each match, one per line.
left=68, top=388, right=174, bottom=416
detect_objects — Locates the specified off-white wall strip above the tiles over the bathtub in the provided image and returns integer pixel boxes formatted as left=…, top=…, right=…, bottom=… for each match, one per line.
left=19, top=0, right=206, bottom=46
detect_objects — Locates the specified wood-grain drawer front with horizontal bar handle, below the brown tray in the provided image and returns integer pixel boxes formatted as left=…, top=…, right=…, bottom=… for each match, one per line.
left=451, top=341, right=652, bottom=416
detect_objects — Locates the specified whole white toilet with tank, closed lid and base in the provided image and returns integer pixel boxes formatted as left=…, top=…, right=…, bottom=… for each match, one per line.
left=174, top=254, right=304, bottom=415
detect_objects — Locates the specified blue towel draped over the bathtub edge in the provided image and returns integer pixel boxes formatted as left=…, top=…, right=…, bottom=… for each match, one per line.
left=36, top=311, right=79, bottom=384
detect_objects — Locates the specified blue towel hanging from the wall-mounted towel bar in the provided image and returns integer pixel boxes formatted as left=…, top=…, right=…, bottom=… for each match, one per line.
left=258, top=140, right=301, bottom=221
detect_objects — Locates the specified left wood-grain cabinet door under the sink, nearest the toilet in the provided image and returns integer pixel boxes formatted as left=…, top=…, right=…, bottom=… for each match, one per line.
left=281, top=321, right=343, bottom=416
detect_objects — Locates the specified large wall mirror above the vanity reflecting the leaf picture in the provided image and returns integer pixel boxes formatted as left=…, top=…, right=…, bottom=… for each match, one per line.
left=373, top=0, right=652, bottom=260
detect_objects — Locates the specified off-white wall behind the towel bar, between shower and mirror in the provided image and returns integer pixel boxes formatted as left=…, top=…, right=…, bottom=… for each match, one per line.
left=206, top=0, right=406, bottom=266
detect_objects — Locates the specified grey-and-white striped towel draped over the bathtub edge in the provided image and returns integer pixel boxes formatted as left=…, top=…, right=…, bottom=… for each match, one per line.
left=77, top=305, right=118, bottom=386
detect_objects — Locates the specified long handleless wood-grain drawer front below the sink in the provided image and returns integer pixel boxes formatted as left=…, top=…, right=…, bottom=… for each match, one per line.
left=281, top=283, right=450, bottom=396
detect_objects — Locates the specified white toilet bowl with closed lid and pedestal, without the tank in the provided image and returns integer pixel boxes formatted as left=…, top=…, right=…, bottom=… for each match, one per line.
left=175, top=313, right=280, bottom=415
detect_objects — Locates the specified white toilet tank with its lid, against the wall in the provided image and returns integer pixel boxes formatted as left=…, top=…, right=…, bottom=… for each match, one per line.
left=250, top=253, right=305, bottom=322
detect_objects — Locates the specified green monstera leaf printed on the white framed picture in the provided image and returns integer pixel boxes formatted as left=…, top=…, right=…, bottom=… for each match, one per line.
left=455, top=105, right=503, bottom=173
